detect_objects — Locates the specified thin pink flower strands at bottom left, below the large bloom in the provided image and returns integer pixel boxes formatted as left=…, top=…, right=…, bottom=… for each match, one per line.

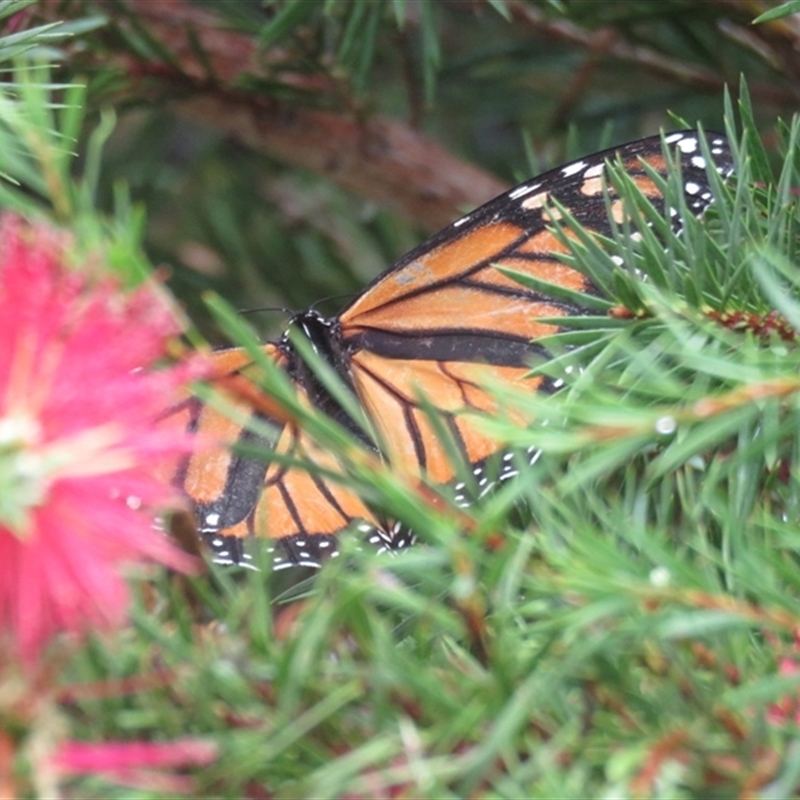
left=52, top=738, right=218, bottom=794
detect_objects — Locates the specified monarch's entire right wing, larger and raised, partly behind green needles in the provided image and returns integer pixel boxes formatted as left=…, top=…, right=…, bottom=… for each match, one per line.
left=340, top=131, right=732, bottom=482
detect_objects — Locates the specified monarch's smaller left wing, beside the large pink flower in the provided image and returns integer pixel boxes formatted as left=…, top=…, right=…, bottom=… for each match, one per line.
left=167, top=344, right=387, bottom=568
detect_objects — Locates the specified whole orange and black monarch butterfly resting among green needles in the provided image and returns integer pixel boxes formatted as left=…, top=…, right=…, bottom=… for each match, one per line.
left=170, top=131, right=732, bottom=569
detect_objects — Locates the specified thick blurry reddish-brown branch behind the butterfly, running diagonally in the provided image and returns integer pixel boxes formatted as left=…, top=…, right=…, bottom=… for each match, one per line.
left=50, top=0, right=508, bottom=230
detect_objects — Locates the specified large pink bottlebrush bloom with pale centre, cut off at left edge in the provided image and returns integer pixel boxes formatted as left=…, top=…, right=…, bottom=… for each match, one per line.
left=0, top=215, right=196, bottom=661
